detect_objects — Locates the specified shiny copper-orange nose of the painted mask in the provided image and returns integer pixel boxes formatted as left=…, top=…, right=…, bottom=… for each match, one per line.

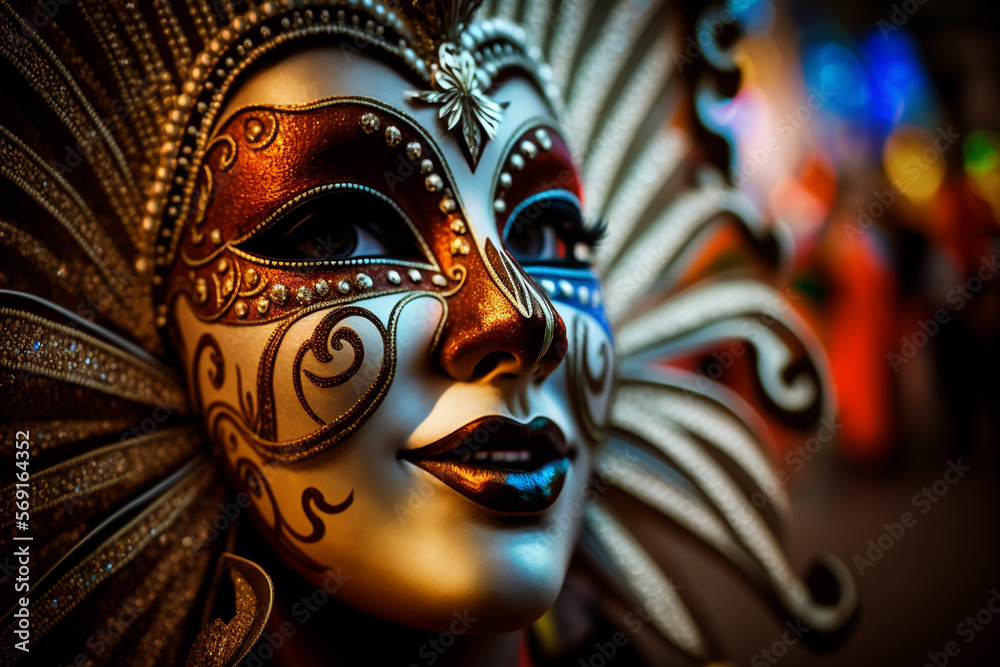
left=437, top=239, right=567, bottom=382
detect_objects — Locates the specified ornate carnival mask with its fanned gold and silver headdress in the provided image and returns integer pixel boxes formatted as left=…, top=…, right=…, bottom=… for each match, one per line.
left=0, top=0, right=857, bottom=665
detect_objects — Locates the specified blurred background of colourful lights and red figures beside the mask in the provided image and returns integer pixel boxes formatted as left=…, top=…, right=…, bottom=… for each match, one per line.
left=681, top=0, right=1000, bottom=667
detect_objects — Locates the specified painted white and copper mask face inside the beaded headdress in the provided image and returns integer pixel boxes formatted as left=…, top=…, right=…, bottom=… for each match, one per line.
left=169, top=47, right=614, bottom=632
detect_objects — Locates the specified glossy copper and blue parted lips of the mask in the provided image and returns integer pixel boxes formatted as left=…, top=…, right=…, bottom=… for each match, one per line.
left=399, top=416, right=573, bottom=512
